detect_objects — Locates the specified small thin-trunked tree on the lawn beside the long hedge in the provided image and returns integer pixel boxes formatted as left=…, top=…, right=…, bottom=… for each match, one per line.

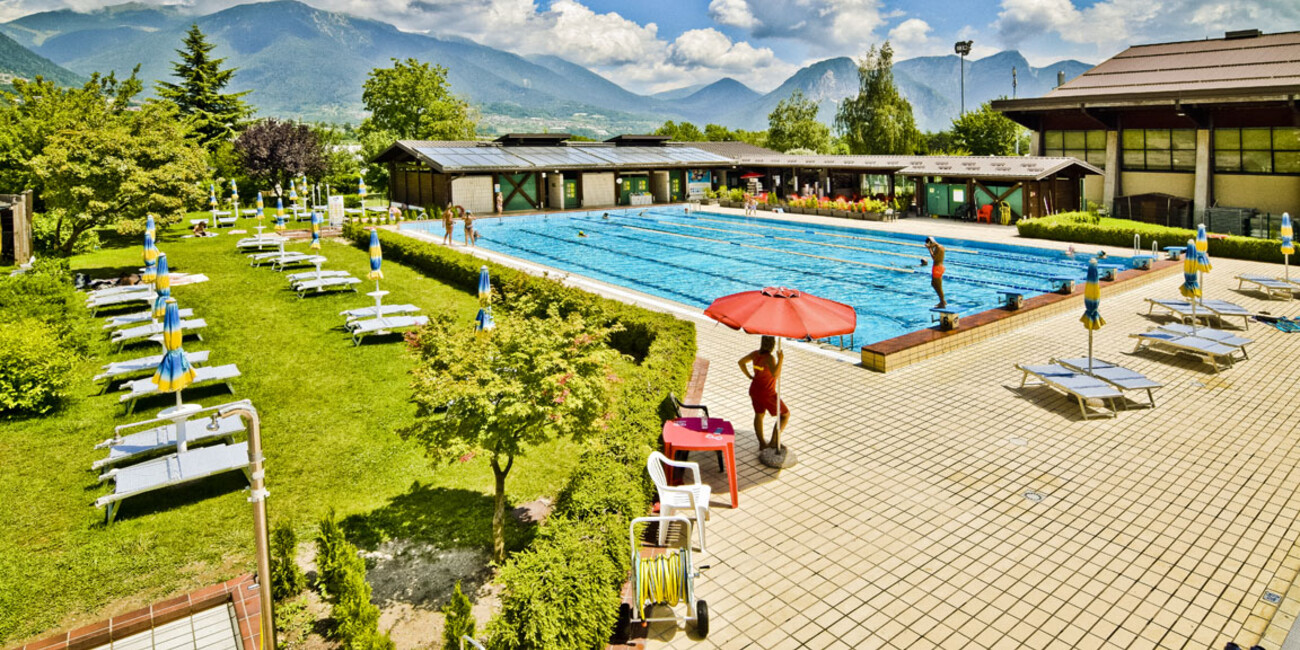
left=404, top=308, right=619, bottom=562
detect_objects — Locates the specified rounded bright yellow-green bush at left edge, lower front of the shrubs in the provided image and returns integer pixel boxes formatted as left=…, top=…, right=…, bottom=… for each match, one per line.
left=0, top=319, right=77, bottom=416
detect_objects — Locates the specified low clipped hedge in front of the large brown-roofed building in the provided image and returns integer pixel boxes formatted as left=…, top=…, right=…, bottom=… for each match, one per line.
left=1015, top=212, right=1282, bottom=264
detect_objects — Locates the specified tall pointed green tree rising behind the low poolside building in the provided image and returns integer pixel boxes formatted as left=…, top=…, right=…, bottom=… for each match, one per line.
left=835, top=40, right=920, bottom=153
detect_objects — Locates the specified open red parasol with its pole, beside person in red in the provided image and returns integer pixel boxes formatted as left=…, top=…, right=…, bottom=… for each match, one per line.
left=705, top=287, right=858, bottom=450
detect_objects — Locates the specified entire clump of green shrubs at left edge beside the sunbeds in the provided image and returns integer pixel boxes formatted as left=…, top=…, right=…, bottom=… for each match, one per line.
left=0, top=260, right=100, bottom=416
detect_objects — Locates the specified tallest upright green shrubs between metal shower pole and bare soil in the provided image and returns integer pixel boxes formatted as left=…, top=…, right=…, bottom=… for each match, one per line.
left=316, top=508, right=394, bottom=650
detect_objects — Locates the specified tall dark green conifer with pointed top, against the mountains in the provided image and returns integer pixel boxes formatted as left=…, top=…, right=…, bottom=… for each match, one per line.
left=159, top=25, right=252, bottom=147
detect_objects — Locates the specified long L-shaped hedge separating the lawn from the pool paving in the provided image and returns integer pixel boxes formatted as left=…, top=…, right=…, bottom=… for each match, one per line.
left=343, top=224, right=696, bottom=650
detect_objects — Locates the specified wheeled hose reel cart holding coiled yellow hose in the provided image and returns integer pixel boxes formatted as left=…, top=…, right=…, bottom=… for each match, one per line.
left=618, top=516, right=709, bottom=638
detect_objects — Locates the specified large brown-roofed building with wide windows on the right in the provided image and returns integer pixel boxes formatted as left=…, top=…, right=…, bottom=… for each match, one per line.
left=993, top=30, right=1300, bottom=234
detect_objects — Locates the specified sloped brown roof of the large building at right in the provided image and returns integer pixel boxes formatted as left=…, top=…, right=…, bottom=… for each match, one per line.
left=993, top=31, right=1300, bottom=111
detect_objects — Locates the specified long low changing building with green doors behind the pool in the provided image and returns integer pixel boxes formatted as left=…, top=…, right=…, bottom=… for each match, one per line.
left=374, top=134, right=1101, bottom=218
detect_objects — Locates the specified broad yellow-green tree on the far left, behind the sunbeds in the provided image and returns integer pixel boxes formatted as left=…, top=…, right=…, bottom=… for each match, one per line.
left=31, top=101, right=207, bottom=255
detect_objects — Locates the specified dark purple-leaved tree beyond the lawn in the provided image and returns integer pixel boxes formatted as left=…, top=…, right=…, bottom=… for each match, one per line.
left=235, top=118, right=330, bottom=187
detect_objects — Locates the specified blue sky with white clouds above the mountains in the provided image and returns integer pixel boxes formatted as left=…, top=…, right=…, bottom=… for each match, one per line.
left=0, top=0, right=1300, bottom=92
